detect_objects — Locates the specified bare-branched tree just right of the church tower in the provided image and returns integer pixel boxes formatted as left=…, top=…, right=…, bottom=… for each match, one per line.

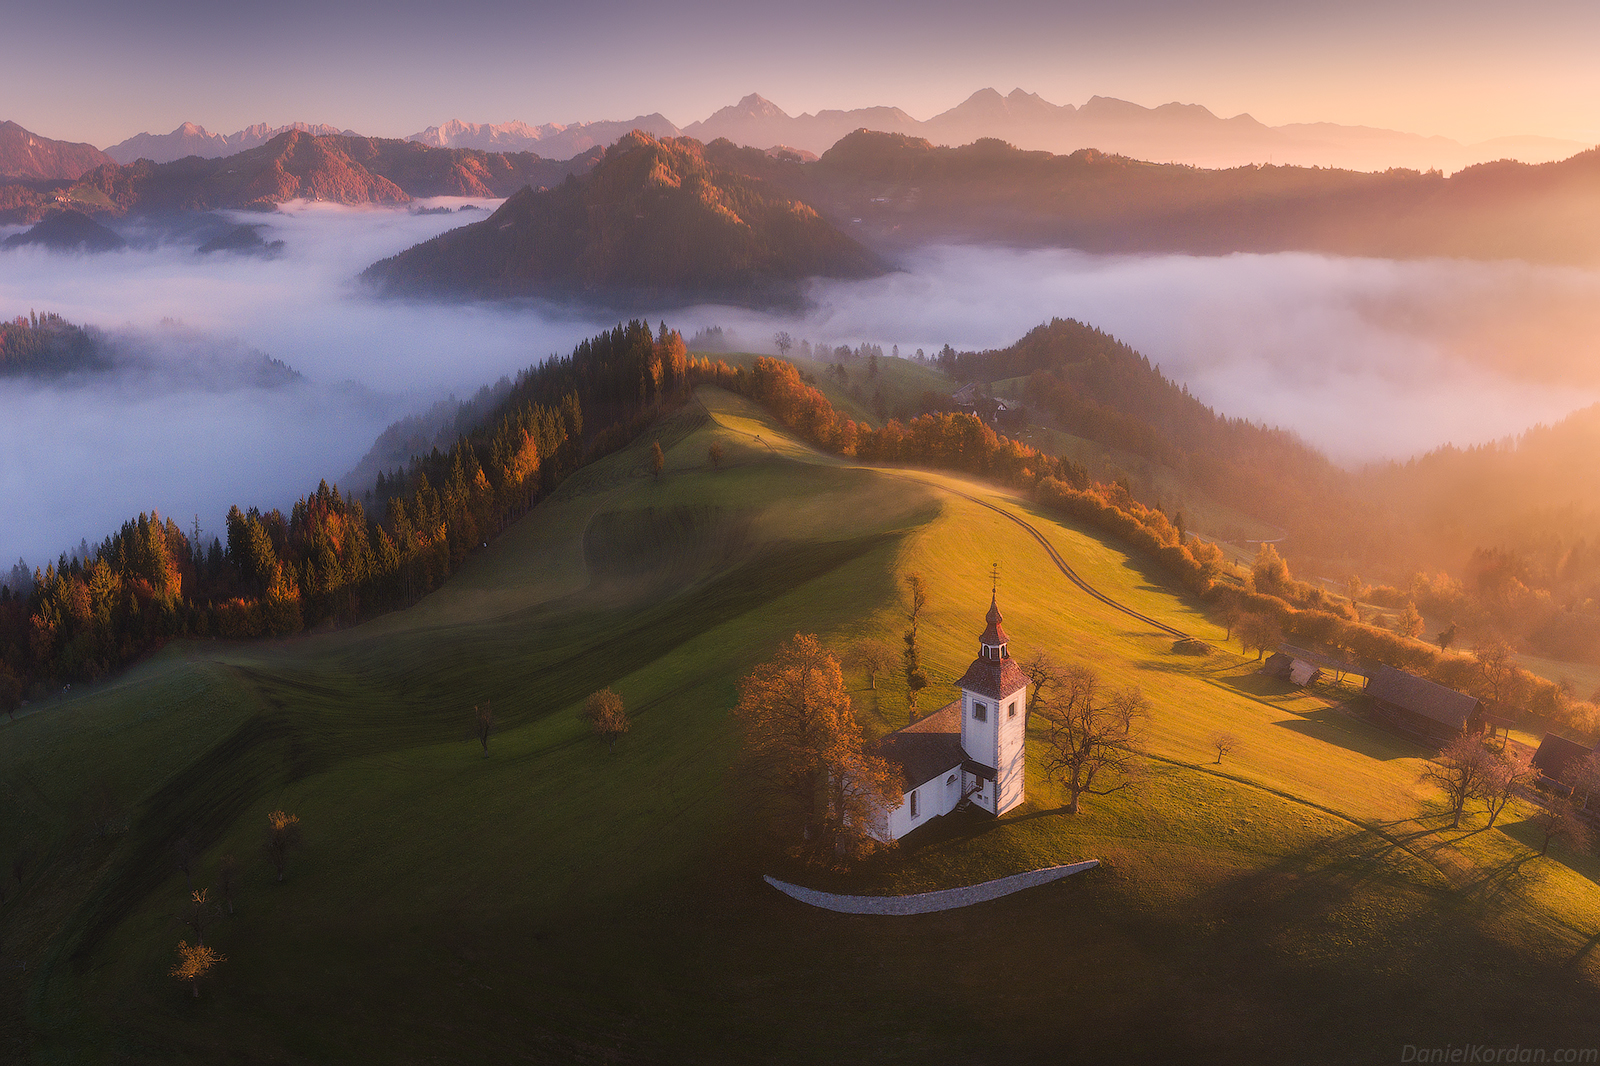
left=1038, top=666, right=1150, bottom=815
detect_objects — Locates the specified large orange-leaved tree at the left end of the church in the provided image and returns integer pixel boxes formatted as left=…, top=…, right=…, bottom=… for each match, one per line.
left=733, top=634, right=901, bottom=861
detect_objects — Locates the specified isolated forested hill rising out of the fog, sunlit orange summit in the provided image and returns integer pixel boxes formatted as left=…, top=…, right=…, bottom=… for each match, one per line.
left=363, top=133, right=885, bottom=304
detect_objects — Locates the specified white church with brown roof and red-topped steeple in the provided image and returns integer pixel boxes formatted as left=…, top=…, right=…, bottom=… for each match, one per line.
left=874, top=599, right=1029, bottom=840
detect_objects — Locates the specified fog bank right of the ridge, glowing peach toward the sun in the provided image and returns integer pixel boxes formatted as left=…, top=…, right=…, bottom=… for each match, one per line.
left=720, top=246, right=1600, bottom=464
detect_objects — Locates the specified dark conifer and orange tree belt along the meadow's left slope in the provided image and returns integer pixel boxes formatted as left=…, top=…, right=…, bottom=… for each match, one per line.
left=0, top=322, right=720, bottom=711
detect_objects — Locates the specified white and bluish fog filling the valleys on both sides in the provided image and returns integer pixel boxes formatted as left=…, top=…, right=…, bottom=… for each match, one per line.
left=0, top=198, right=1600, bottom=565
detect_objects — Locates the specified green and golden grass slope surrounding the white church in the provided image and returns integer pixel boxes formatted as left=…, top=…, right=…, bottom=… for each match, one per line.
left=0, top=389, right=1600, bottom=1063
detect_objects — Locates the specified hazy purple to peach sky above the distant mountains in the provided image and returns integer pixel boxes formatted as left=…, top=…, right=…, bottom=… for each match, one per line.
left=0, top=0, right=1600, bottom=147
